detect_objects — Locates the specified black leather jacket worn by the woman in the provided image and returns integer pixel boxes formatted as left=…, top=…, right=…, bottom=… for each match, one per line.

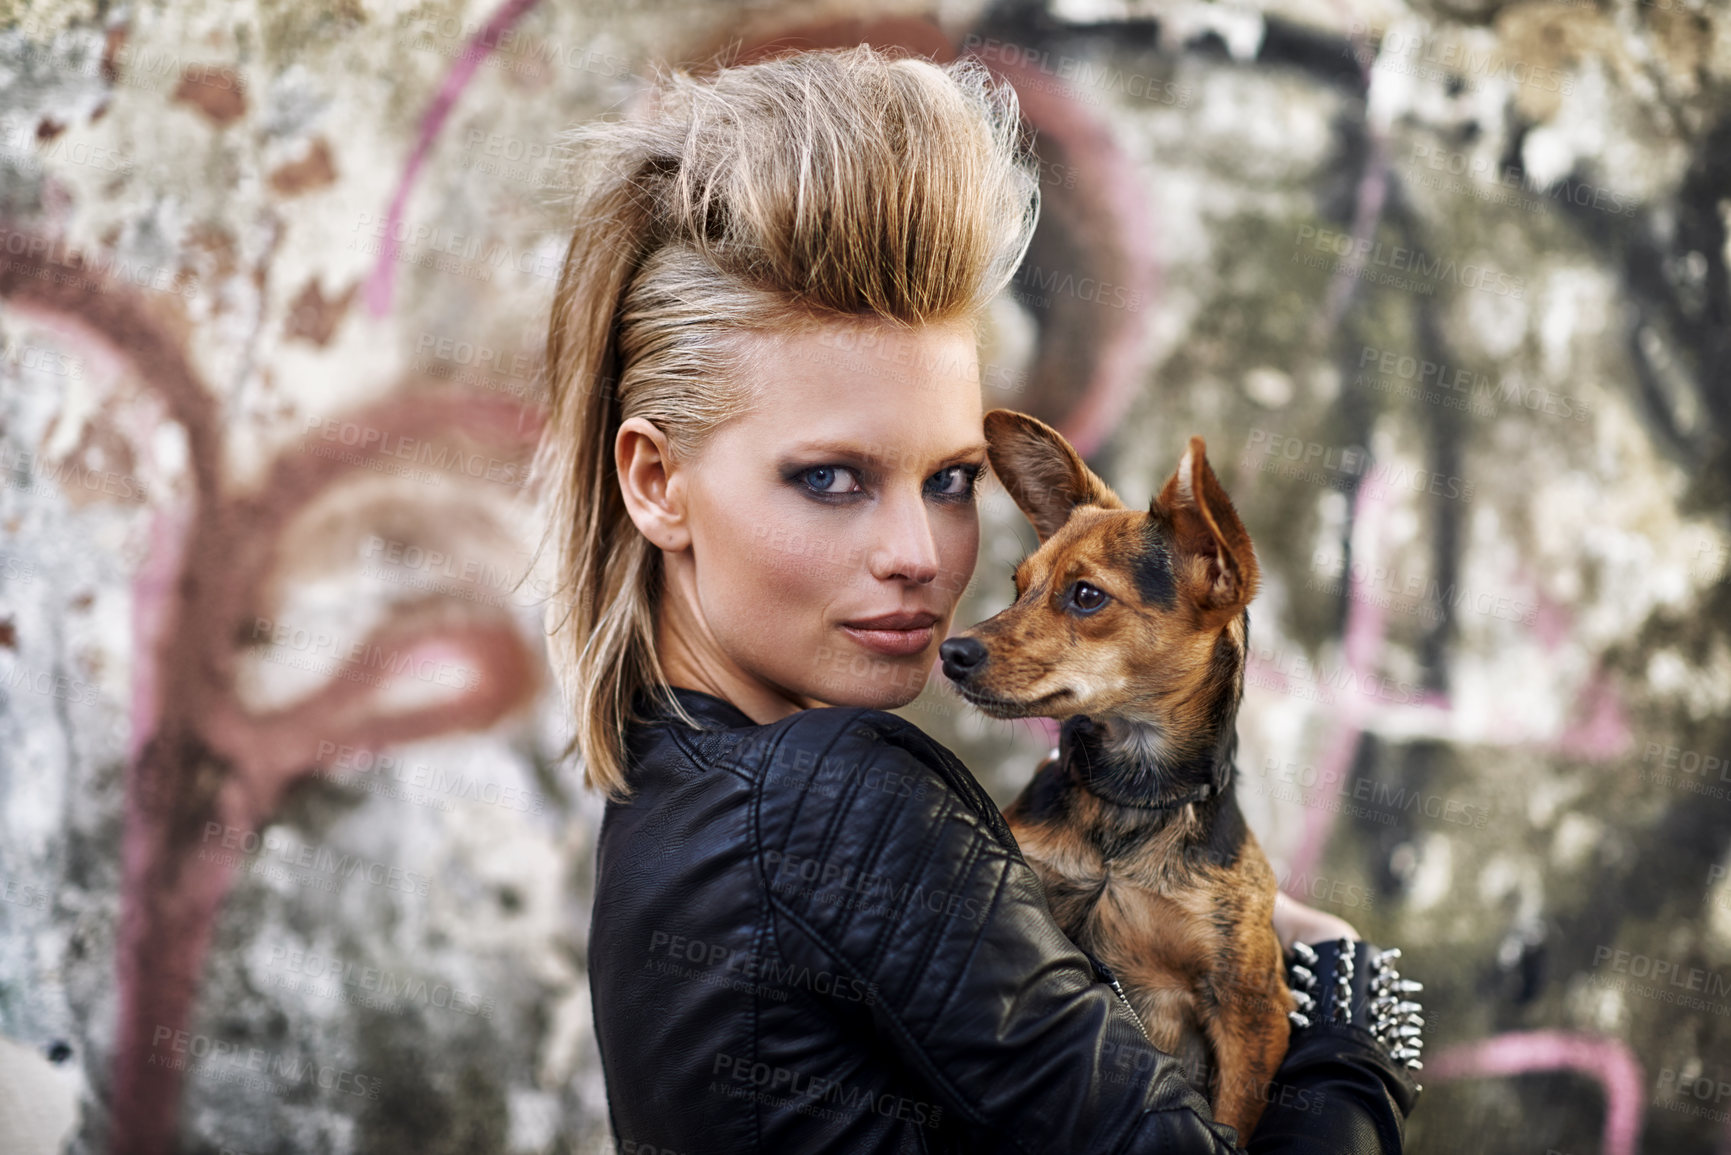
left=589, top=689, right=1418, bottom=1155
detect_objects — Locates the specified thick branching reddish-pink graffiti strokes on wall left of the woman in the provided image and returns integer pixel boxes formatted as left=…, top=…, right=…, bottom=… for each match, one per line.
left=0, top=237, right=542, bottom=1155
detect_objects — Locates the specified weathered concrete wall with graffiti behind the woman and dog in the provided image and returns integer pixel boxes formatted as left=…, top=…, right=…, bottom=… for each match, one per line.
left=0, top=0, right=1731, bottom=1153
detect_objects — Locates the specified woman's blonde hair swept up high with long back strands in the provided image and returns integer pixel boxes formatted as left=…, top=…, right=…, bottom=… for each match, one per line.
left=533, top=45, right=1040, bottom=798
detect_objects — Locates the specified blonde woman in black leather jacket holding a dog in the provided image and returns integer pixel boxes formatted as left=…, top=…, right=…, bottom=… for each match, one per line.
left=537, top=47, right=1418, bottom=1155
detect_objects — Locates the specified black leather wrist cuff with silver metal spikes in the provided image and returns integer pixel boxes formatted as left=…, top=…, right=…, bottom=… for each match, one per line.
left=1286, top=939, right=1425, bottom=1094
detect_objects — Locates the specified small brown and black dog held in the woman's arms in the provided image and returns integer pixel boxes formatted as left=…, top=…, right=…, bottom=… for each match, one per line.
left=938, top=409, right=1297, bottom=1143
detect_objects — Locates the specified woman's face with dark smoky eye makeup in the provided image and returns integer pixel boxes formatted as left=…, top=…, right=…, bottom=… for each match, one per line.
left=621, top=316, right=987, bottom=722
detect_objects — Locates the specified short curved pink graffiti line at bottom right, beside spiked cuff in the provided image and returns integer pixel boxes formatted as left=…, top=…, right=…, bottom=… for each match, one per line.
left=1425, top=1030, right=1646, bottom=1155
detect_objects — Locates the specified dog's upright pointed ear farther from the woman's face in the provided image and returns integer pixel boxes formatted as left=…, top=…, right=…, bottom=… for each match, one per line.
left=1149, top=436, right=1260, bottom=610
